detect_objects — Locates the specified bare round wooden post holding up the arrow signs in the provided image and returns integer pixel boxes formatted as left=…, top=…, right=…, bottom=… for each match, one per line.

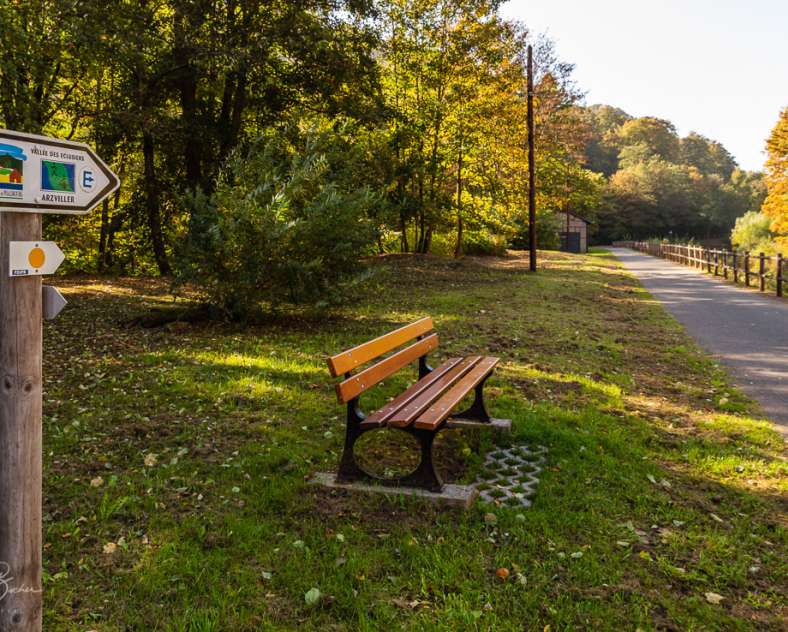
left=0, top=213, right=42, bottom=632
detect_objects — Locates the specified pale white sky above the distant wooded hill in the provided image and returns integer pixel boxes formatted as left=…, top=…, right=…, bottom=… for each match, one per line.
left=502, top=0, right=788, bottom=170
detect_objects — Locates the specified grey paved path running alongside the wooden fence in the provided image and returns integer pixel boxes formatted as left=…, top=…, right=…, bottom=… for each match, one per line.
left=610, top=248, right=788, bottom=437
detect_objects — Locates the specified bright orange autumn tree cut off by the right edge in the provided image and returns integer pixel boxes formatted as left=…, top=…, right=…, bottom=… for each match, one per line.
left=763, top=107, right=788, bottom=248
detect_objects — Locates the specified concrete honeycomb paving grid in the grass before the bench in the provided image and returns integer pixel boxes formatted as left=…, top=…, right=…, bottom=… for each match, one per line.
left=475, top=445, right=547, bottom=507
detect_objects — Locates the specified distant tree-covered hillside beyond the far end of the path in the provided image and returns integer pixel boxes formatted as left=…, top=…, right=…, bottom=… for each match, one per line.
left=586, top=106, right=764, bottom=243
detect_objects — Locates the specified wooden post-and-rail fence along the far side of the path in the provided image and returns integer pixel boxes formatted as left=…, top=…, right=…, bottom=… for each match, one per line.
left=617, top=241, right=788, bottom=296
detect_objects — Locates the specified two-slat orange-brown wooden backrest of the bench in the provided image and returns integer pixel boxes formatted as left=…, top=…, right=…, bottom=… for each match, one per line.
left=328, top=316, right=438, bottom=402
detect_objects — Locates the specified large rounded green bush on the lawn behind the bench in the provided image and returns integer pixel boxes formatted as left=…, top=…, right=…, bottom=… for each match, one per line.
left=177, top=129, right=377, bottom=319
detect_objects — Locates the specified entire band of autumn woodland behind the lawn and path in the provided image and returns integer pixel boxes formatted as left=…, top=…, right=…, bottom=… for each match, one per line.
left=0, top=0, right=785, bottom=288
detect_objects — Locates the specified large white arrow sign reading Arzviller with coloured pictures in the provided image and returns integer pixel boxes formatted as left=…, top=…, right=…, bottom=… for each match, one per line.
left=0, top=130, right=120, bottom=215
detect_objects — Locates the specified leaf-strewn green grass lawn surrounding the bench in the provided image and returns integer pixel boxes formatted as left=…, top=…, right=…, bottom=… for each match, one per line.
left=44, top=252, right=788, bottom=632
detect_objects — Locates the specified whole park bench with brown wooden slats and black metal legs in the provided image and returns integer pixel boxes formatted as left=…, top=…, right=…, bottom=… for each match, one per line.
left=328, top=317, right=504, bottom=492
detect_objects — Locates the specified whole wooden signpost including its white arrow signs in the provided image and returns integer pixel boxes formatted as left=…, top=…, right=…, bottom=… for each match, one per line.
left=0, top=130, right=120, bottom=632
